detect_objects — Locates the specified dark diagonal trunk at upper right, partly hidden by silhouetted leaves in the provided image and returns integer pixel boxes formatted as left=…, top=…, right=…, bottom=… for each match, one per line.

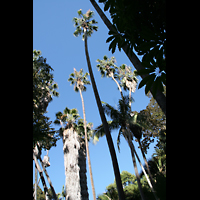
left=90, top=0, right=166, bottom=116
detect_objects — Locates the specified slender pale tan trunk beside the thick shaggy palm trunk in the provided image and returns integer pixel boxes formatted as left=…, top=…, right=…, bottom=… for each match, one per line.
left=79, top=88, right=96, bottom=200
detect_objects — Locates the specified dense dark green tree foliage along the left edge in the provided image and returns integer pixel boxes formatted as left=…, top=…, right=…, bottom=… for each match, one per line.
left=33, top=50, right=59, bottom=149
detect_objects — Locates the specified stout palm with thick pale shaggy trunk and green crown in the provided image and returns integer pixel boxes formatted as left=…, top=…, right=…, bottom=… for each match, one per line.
left=54, top=107, right=89, bottom=200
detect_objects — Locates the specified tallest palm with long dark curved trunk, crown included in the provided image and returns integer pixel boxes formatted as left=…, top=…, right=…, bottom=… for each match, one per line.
left=73, top=10, right=125, bottom=200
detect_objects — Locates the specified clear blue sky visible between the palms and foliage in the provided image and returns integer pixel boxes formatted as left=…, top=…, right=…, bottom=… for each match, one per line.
left=33, top=0, right=158, bottom=200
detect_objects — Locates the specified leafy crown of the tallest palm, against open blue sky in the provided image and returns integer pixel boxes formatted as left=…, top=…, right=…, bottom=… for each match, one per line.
left=73, top=9, right=98, bottom=40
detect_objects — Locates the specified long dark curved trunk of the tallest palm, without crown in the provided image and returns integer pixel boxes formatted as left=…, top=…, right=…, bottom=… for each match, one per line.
left=84, top=29, right=125, bottom=200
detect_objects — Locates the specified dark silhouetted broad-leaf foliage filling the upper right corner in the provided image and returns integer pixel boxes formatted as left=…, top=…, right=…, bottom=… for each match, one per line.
left=99, top=0, right=166, bottom=97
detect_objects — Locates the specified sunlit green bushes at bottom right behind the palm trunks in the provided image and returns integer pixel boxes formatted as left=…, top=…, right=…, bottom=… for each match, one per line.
left=97, top=139, right=166, bottom=200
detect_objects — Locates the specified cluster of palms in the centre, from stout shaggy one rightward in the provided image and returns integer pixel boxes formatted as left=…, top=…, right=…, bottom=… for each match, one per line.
left=33, top=9, right=162, bottom=200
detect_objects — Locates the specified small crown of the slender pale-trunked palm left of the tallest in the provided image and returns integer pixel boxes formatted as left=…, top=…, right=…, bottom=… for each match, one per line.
left=68, top=68, right=91, bottom=92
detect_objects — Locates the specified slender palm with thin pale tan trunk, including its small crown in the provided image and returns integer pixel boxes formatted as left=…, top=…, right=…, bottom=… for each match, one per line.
left=68, top=68, right=96, bottom=200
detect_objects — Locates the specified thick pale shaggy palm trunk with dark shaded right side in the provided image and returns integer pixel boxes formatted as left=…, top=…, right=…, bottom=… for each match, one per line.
left=63, top=128, right=88, bottom=200
